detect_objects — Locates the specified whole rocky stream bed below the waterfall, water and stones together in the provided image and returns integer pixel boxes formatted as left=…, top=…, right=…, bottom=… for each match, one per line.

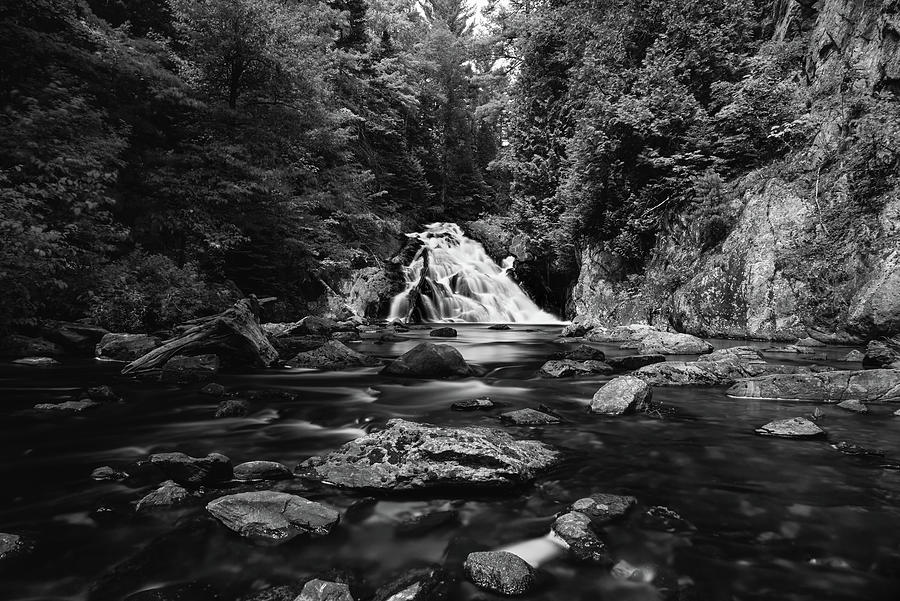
left=0, top=324, right=900, bottom=601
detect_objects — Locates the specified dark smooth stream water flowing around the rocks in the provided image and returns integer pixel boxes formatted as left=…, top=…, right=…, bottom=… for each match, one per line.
left=0, top=326, right=900, bottom=601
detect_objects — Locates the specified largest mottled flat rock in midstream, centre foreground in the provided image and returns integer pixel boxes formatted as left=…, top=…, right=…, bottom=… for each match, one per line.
left=296, top=419, right=558, bottom=491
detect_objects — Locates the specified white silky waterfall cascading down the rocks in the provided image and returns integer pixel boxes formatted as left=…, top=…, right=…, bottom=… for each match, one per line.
left=391, top=223, right=560, bottom=324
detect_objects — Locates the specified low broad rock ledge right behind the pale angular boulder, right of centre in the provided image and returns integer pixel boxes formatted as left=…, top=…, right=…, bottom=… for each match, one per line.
left=633, top=346, right=813, bottom=386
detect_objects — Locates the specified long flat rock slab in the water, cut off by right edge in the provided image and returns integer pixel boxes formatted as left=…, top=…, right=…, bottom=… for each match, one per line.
left=728, top=369, right=900, bottom=403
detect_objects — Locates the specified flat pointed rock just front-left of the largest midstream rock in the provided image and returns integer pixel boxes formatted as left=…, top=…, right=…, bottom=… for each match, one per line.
left=206, top=490, right=340, bottom=543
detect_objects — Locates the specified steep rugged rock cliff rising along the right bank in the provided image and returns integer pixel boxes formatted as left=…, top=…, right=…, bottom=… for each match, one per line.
left=572, top=0, right=900, bottom=342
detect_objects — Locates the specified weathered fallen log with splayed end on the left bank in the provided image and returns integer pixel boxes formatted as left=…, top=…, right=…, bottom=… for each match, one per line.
left=122, top=296, right=278, bottom=374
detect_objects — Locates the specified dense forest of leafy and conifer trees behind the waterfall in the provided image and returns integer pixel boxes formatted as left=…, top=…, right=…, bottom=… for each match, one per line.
left=0, top=0, right=900, bottom=338
